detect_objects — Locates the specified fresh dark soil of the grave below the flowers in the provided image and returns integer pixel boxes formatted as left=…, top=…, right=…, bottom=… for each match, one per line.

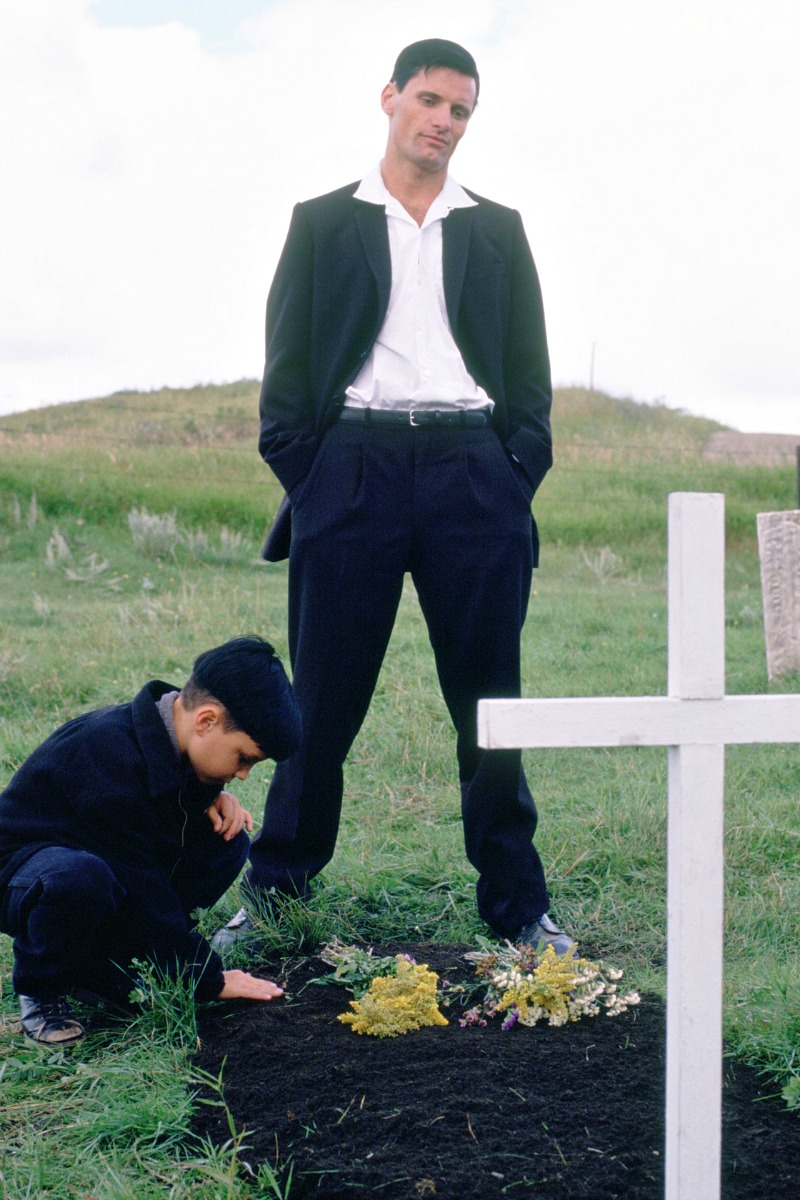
left=194, top=946, right=800, bottom=1200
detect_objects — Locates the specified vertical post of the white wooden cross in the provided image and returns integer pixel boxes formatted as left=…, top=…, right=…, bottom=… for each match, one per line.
left=664, top=492, right=724, bottom=1200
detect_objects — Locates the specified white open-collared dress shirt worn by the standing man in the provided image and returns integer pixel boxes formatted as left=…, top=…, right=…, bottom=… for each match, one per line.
left=344, top=166, right=494, bottom=409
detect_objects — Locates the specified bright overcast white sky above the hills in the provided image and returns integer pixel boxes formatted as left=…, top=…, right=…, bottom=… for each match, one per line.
left=0, top=0, right=800, bottom=433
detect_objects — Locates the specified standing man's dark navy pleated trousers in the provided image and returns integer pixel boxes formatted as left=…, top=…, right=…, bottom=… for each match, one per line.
left=247, top=422, right=548, bottom=937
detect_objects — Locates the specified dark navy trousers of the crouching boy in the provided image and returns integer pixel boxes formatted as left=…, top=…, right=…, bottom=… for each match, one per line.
left=0, top=824, right=248, bottom=998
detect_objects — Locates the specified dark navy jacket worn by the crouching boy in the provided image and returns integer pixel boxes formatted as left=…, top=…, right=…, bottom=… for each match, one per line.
left=0, top=680, right=231, bottom=998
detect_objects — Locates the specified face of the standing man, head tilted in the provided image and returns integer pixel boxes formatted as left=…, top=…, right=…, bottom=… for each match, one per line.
left=380, top=67, right=476, bottom=173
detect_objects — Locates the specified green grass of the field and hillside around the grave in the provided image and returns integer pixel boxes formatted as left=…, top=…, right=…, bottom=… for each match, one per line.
left=0, top=382, right=800, bottom=1200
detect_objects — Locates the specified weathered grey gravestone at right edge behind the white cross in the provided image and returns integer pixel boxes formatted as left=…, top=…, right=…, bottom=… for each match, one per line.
left=757, top=511, right=800, bottom=679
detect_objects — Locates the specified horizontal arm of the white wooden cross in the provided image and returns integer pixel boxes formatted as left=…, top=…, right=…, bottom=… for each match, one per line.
left=477, top=695, right=800, bottom=750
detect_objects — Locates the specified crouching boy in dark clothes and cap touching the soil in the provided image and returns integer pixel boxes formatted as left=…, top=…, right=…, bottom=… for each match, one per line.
left=0, top=637, right=300, bottom=1045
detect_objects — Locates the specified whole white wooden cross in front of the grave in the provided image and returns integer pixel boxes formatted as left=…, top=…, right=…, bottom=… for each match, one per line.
left=477, top=492, right=800, bottom=1200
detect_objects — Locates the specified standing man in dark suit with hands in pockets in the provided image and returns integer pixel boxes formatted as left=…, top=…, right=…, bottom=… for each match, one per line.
left=216, top=38, right=573, bottom=954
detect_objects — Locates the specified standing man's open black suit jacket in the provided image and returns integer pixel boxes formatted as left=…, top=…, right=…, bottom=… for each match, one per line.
left=259, top=184, right=553, bottom=560
